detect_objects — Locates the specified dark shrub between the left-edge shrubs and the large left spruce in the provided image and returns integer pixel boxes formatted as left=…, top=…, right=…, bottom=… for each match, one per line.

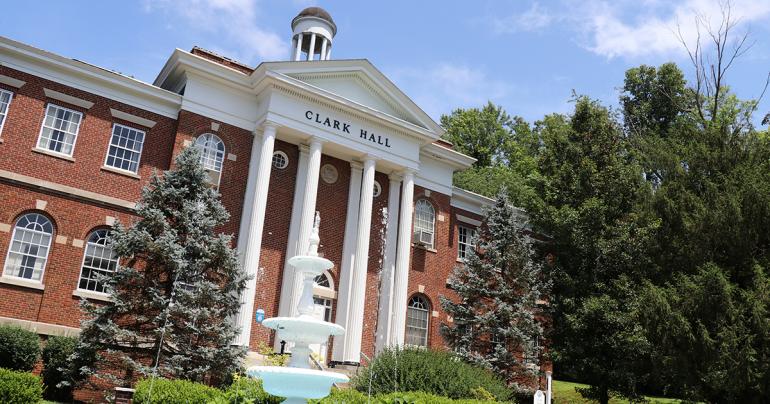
left=41, top=337, right=78, bottom=401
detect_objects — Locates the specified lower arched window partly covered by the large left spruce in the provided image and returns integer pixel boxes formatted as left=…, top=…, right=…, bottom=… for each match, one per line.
left=78, top=229, right=118, bottom=293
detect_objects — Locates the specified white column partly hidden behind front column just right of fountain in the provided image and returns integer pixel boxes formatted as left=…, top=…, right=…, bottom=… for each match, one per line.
left=332, top=161, right=364, bottom=362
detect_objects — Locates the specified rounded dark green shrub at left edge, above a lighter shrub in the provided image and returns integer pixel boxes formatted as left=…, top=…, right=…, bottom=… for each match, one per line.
left=0, top=326, right=40, bottom=371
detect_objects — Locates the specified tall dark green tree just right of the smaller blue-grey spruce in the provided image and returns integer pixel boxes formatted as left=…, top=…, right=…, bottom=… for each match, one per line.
left=528, top=97, right=657, bottom=403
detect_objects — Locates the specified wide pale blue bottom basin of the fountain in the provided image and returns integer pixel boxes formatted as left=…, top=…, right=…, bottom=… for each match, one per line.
left=246, top=366, right=350, bottom=402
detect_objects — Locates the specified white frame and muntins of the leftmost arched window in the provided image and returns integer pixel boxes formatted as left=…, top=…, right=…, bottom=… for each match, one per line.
left=2, top=212, right=56, bottom=284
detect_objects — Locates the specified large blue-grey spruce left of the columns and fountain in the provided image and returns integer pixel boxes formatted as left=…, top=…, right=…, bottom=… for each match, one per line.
left=72, top=147, right=247, bottom=385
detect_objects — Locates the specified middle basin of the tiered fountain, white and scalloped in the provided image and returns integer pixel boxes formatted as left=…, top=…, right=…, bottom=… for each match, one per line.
left=262, top=315, right=345, bottom=344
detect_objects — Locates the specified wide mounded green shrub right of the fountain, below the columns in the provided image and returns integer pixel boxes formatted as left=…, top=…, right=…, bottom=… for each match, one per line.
left=351, top=348, right=513, bottom=401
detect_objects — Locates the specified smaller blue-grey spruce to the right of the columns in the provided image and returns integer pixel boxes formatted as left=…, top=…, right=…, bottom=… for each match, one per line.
left=441, top=189, right=548, bottom=387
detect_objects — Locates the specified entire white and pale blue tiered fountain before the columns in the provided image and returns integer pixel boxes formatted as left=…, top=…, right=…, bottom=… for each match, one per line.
left=247, top=212, right=348, bottom=404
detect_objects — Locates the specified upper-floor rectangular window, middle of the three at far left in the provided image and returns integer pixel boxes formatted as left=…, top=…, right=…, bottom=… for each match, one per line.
left=37, top=104, right=83, bottom=156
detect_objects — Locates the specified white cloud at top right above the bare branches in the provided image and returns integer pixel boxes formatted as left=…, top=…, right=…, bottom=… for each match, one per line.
left=569, top=0, right=770, bottom=58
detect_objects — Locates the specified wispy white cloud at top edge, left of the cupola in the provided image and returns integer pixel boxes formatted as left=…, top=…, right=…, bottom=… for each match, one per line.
left=144, top=0, right=289, bottom=63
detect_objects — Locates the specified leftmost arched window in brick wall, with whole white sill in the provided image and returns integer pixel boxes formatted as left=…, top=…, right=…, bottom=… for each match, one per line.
left=3, top=213, right=53, bottom=282
